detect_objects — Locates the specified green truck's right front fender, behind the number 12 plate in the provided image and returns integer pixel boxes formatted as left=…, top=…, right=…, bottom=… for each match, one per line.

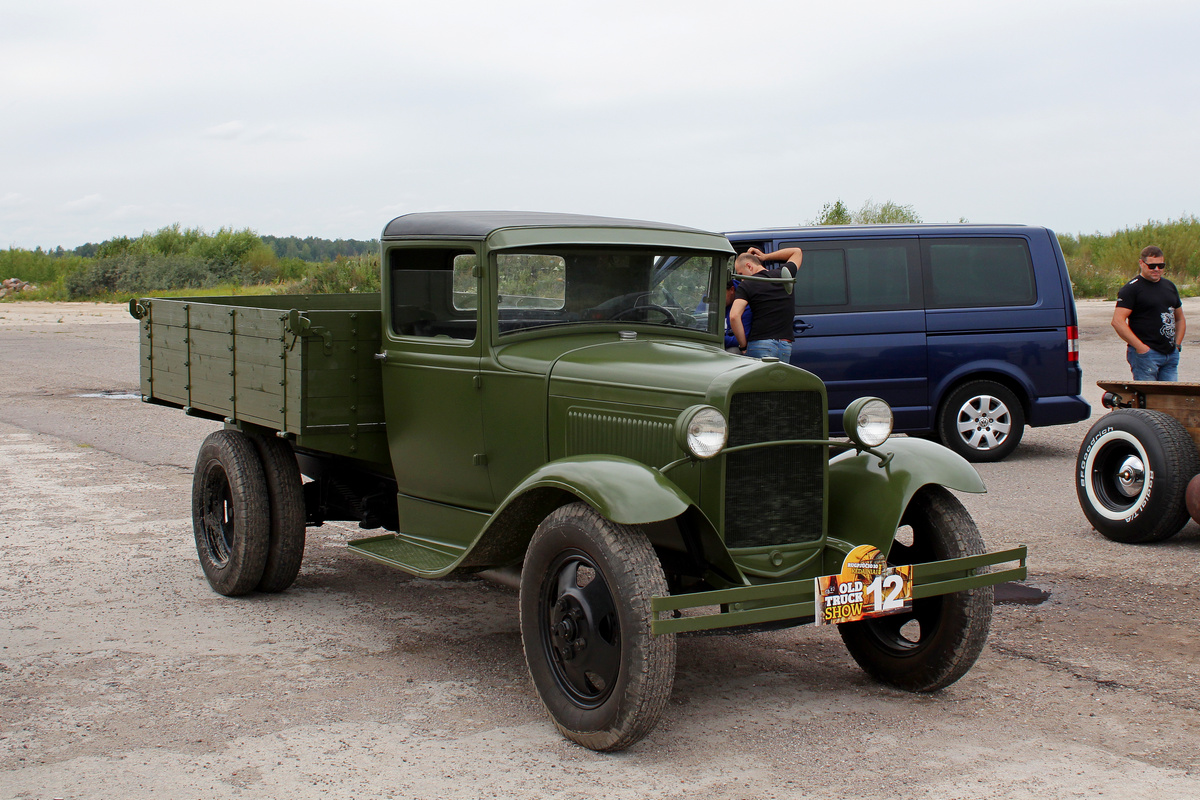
left=826, top=438, right=988, bottom=566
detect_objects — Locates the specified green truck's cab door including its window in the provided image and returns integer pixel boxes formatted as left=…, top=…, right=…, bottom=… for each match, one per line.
left=379, top=242, right=494, bottom=513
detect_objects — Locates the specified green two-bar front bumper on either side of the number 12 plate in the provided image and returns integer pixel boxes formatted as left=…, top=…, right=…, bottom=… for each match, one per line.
left=650, top=545, right=1027, bottom=633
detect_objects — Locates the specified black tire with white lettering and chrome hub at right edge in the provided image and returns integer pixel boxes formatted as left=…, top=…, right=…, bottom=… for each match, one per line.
left=1075, top=409, right=1200, bottom=543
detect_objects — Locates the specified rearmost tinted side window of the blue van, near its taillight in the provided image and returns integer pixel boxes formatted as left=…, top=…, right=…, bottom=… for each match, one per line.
left=922, top=239, right=1038, bottom=308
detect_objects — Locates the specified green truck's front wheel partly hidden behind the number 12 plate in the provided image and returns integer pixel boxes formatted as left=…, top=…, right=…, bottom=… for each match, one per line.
left=838, top=486, right=995, bottom=692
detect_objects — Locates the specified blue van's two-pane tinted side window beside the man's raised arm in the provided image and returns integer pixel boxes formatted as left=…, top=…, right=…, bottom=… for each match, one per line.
left=781, top=241, right=919, bottom=311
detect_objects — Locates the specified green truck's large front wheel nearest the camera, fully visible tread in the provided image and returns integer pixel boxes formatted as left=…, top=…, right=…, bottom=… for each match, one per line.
left=521, top=503, right=676, bottom=751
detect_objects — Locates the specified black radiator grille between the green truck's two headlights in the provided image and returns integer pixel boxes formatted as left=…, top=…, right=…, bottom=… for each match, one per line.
left=725, top=391, right=826, bottom=547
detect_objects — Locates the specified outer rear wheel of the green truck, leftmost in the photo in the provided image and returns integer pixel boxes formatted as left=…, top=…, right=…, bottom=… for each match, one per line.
left=192, top=431, right=271, bottom=597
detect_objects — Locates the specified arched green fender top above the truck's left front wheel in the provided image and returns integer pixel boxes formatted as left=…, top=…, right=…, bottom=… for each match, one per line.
left=504, top=456, right=691, bottom=525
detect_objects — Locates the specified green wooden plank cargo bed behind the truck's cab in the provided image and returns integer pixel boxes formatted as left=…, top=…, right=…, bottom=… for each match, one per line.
left=130, top=294, right=389, bottom=465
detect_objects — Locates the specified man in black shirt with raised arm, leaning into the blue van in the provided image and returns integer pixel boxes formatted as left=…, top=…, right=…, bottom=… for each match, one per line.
left=730, top=247, right=804, bottom=362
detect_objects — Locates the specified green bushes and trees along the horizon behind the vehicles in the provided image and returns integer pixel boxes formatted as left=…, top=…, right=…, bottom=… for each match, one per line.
left=0, top=208, right=1200, bottom=300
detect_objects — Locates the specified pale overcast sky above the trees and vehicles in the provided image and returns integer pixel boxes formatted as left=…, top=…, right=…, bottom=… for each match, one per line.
left=0, top=0, right=1200, bottom=248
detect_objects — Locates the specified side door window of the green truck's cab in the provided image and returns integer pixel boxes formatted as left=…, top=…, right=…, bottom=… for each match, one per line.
left=388, top=248, right=479, bottom=341
